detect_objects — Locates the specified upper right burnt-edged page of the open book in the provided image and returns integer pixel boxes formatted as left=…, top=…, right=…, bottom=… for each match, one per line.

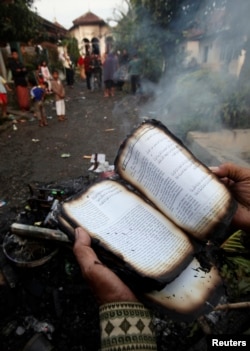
left=115, top=120, right=236, bottom=242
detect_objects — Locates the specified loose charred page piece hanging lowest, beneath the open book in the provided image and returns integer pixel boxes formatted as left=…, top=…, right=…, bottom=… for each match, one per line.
left=144, top=258, right=225, bottom=321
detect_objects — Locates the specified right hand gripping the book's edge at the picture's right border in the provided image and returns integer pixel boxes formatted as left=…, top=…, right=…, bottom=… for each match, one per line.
left=210, top=163, right=250, bottom=231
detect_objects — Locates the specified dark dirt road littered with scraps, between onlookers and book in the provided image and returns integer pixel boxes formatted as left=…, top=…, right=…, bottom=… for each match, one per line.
left=0, top=81, right=139, bottom=229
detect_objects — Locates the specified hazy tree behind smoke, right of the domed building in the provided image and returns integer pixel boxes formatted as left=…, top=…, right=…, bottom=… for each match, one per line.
left=114, top=0, right=204, bottom=80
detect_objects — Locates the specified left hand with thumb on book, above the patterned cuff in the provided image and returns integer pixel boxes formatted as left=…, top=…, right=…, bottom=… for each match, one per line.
left=73, top=227, right=137, bottom=305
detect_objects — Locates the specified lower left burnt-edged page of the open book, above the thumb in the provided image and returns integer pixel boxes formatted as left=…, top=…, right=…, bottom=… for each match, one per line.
left=61, top=180, right=195, bottom=288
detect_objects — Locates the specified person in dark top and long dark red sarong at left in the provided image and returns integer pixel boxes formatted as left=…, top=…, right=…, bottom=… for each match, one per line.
left=9, top=49, right=30, bottom=111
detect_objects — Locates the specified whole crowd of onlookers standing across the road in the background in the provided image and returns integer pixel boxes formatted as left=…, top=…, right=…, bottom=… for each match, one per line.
left=0, top=49, right=142, bottom=127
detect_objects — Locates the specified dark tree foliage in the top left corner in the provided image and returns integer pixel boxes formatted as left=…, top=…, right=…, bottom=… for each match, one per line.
left=0, top=0, right=38, bottom=43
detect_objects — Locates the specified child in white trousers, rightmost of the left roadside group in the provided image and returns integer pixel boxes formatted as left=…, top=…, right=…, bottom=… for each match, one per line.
left=51, top=70, right=66, bottom=122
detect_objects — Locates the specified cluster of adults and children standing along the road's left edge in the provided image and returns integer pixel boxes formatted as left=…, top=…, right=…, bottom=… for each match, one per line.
left=0, top=49, right=66, bottom=127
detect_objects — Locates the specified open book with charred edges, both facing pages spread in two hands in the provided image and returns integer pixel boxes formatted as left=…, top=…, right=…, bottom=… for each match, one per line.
left=59, top=120, right=236, bottom=318
